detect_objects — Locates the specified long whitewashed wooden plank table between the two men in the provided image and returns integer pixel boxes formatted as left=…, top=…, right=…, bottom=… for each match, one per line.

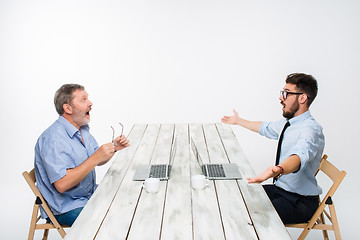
left=65, top=123, right=291, bottom=240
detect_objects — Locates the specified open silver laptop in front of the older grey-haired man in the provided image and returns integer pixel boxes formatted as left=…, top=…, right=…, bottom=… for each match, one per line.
left=133, top=139, right=177, bottom=181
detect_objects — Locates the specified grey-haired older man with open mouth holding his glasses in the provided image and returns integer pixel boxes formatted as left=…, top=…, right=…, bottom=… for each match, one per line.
left=35, top=84, right=129, bottom=226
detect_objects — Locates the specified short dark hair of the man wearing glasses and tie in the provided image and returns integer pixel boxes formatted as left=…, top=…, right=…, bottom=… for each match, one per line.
left=285, top=73, right=318, bottom=107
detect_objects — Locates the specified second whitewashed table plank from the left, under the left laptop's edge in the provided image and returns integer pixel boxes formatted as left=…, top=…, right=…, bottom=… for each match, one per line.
left=96, top=124, right=160, bottom=240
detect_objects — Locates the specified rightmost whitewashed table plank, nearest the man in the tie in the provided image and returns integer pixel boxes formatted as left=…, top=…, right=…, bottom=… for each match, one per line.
left=216, top=123, right=291, bottom=239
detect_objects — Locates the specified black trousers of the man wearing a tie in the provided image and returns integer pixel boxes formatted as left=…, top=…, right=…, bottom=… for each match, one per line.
left=263, top=184, right=319, bottom=224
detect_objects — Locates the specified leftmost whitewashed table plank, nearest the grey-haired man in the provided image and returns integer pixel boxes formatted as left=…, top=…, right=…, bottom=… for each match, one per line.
left=65, top=125, right=146, bottom=240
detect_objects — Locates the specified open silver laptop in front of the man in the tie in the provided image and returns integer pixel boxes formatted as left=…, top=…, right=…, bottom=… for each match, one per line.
left=191, top=138, right=242, bottom=180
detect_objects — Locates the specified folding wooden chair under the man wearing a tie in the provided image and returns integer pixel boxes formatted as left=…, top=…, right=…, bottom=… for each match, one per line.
left=285, top=154, right=346, bottom=240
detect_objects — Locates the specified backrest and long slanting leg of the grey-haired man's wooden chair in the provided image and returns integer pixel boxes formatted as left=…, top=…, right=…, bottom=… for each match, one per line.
left=22, top=169, right=65, bottom=232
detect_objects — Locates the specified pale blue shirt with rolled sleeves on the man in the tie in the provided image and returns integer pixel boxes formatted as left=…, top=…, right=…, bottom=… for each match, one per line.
left=259, top=111, right=325, bottom=196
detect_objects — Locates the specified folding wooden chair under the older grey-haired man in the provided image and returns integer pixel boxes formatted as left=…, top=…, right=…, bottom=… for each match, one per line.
left=22, top=169, right=67, bottom=240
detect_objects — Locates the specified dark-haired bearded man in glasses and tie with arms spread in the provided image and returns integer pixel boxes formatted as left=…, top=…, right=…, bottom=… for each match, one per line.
left=222, top=73, right=325, bottom=224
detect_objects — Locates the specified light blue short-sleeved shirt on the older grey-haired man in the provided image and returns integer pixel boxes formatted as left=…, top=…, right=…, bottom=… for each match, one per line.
left=35, top=116, right=98, bottom=218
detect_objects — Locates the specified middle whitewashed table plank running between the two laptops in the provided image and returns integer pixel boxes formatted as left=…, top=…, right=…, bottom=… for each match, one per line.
left=160, top=124, right=193, bottom=240
